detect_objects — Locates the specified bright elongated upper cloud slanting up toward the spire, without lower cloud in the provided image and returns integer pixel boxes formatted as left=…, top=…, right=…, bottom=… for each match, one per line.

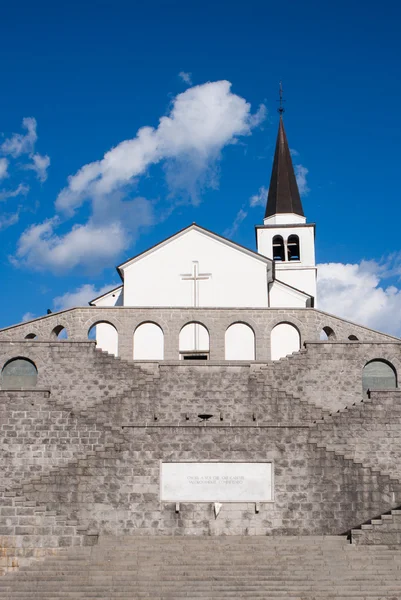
left=56, top=81, right=265, bottom=214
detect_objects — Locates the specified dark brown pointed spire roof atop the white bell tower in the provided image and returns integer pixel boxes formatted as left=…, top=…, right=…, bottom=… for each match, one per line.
left=265, top=114, right=304, bottom=219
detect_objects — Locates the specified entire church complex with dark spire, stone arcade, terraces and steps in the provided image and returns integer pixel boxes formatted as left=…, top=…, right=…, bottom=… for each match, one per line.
left=0, top=112, right=401, bottom=600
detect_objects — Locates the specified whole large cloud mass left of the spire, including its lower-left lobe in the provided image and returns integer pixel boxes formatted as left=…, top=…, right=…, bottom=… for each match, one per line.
left=13, top=81, right=266, bottom=272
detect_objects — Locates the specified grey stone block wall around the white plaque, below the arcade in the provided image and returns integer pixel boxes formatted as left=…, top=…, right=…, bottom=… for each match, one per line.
left=0, top=340, right=401, bottom=544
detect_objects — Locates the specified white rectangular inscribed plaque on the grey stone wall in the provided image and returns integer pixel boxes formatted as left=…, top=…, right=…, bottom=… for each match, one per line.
left=160, top=462, right=273, bottom=502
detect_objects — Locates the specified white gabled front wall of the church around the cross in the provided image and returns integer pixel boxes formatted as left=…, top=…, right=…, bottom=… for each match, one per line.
left=124, top=229, right=269, bottom=307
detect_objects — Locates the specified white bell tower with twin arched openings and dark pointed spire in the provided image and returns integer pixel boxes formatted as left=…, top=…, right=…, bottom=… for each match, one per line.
left=256, top=94, right=316, bottom=306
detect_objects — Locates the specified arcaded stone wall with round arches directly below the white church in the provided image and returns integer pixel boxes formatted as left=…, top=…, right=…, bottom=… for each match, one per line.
left=0, top=307, right=396, bottom=361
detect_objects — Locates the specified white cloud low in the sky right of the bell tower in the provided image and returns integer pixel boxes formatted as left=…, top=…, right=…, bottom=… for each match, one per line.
left=318, top=257, right=401, bottom=336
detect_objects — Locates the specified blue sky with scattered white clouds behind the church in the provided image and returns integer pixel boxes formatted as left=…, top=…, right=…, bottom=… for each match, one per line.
left=0, top=0, right=401, bottom=335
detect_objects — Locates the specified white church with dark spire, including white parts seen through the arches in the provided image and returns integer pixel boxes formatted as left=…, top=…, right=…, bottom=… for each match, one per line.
left=90, top=116, right=316, bottom=360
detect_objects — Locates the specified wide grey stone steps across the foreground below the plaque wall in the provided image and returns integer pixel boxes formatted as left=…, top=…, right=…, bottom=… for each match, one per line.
left=0, top=536, right=401, bottom=600
